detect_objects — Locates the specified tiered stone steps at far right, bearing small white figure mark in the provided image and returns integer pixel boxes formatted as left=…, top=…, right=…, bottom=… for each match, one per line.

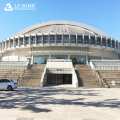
left=97, top=70, right=120, bottom=88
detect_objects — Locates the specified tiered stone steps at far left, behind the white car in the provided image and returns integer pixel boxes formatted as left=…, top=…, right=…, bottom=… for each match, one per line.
left=0, top=69, right=24, bottom=82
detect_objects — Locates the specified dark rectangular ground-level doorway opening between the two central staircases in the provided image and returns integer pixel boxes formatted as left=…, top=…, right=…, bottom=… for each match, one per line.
left=47, top=74, right=72, bottom=84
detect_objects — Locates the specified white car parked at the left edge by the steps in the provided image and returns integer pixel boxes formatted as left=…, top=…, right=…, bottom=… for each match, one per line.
left=0, top=79, right=18, bottom=91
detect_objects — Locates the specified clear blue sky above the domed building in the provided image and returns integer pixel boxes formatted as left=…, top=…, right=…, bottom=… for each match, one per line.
left=0, top=0, right=120, bottom=41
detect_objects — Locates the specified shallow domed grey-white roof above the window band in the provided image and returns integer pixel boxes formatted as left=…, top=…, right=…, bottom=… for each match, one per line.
left=12, top=20, right=109, bottom=37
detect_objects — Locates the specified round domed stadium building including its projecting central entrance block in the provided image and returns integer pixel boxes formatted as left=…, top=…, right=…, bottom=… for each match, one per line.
left=0, top=20, right=120, bottom=86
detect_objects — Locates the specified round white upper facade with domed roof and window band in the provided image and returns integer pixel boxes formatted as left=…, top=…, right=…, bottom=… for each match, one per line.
left=0, top=21, right=120, bottom=64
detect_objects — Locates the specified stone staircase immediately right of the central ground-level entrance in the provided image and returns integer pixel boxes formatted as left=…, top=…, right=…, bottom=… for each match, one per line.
left=75, top=65, right=104, bottom=88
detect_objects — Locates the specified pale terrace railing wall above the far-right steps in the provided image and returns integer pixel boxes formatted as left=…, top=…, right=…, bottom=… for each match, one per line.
left=90, top=60, right=120, bottom=66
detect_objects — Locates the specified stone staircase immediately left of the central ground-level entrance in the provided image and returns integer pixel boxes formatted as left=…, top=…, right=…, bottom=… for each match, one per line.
left=19, top=64, right=45, bottom=87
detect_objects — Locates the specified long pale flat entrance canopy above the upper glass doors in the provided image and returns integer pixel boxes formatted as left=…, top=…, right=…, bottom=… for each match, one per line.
left=28, top=51, right=92, bottom=55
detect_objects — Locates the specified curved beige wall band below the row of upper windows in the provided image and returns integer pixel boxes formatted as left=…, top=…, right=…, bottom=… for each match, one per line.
left=2, top=46, right=119, bottom=61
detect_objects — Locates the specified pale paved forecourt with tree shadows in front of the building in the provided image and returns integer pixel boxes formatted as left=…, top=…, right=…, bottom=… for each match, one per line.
left=0, top=85, right=120, bottom=120
